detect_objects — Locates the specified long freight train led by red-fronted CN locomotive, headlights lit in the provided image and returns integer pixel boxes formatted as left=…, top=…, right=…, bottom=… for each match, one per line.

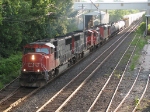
left=19, top=13, right=144, bottom=87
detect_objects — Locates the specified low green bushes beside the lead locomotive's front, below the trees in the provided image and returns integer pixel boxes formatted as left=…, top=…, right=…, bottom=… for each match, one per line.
left=0, top=53, right=22, bottom=88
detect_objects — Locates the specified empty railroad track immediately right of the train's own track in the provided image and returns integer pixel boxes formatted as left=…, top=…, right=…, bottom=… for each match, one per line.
left=34, top=19, right=143, bottom=112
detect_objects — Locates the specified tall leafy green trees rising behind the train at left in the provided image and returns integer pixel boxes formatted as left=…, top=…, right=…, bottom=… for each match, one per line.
left=0, top=0, right=76, bottom=58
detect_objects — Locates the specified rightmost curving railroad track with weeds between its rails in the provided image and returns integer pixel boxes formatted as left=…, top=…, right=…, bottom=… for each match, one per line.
left=111, top=68, right=150, bottom=112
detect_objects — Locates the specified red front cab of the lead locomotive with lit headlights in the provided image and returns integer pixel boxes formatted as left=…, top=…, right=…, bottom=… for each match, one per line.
left=20, top=42, right=56, bottom=87
